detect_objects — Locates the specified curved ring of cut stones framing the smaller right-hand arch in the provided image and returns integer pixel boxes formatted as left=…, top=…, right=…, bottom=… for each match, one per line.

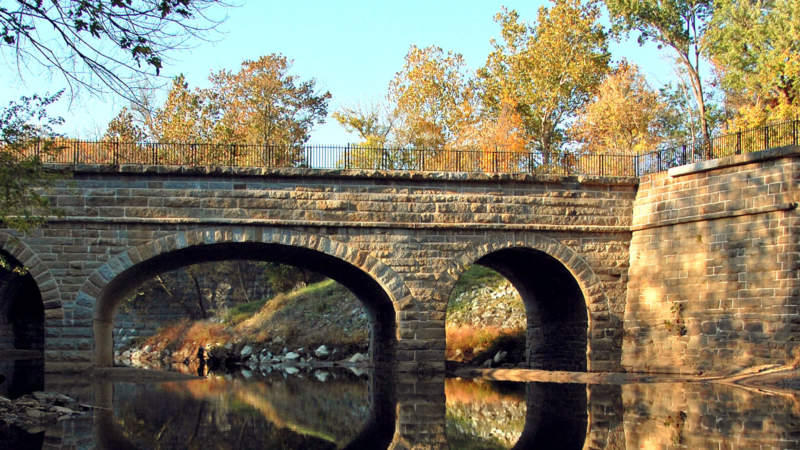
left=443, top=233, right=622, bottom=371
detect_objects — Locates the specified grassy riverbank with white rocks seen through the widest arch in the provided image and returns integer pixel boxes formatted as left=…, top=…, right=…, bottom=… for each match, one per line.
left=115, top=280, right=369, bottom=368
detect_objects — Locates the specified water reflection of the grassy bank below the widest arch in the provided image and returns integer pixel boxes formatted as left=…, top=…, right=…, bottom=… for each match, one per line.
left=104, top=374, right=370, bottom=448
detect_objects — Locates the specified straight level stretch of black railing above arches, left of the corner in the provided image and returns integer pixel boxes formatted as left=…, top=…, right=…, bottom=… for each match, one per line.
left=18, top=139, right=635, bottom=176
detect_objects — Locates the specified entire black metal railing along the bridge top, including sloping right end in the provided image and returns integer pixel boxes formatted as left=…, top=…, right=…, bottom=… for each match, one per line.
left=12, top=120, right=800, bottom=177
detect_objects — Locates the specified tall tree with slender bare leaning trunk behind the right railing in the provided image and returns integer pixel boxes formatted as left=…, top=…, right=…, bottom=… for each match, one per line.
left=605, top=0, right=713, bottom=154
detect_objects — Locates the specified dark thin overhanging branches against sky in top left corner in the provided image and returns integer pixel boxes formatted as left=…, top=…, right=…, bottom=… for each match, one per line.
left=0, top=0, right=228, bottom=100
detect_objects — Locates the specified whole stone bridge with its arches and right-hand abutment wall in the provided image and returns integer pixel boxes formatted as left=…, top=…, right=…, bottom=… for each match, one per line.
left=0, top=147, right=800, bottom=372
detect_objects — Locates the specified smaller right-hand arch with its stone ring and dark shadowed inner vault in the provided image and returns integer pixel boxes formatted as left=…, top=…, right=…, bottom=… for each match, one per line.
left=443, top=233, right=622, bottom=371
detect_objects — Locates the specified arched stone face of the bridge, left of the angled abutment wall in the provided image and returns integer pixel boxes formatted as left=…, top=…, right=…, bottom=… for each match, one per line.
left=0, top=166, right=636, bottom=370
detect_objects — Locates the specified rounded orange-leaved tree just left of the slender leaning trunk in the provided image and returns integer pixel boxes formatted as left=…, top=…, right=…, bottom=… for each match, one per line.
left=570, top=61, right=668, bottom=154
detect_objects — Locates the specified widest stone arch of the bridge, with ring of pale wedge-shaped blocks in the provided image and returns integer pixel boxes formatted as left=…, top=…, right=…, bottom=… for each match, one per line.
left=76, top=227, right=410, bottom=367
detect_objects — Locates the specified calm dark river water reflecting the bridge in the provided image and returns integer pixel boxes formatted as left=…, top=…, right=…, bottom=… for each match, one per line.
left=0, top=356, right=800, bottom=449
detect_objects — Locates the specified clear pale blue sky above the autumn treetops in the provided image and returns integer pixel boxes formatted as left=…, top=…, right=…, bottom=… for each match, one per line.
left=0, top=0, right=674, bottom=144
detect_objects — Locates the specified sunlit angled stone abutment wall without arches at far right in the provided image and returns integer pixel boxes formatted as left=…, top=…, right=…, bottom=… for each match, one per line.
left=622, top=148, right=800, bottom=374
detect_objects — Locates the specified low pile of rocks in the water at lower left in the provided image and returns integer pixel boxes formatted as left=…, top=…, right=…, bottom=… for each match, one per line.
left=0, top=392, right=92, bottom=432
